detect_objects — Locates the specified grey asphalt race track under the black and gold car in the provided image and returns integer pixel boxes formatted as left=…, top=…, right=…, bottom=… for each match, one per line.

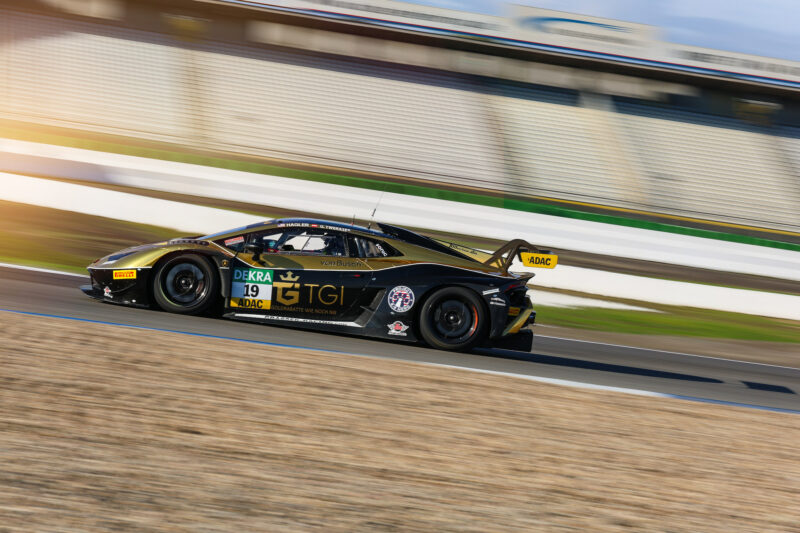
left=0, top=267, right=800, bottom=412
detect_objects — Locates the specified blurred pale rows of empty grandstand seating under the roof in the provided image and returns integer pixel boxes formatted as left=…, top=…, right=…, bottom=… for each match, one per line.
left=0, top=2, right=800, bottom=231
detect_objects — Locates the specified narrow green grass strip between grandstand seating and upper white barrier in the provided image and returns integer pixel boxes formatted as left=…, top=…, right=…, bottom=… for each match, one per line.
left=6, top=127, right=800, bottom=251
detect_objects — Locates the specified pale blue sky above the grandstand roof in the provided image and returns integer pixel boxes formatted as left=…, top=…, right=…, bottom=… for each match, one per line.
left=408, top=0, right=800, bottom=61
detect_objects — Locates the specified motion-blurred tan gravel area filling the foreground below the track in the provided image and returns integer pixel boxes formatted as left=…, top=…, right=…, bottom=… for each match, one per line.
left=0, top=313, right=800, bottom=533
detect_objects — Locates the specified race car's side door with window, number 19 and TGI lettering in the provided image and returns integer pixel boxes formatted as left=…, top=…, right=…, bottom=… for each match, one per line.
left=230, top=225, right=370, bottom=321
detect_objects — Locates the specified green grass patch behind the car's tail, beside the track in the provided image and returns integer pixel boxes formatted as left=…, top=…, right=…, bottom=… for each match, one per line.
left=536, top=302, right=800, bottom=343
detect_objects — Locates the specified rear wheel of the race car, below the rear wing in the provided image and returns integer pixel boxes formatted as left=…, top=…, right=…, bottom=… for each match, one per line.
left=419, top=287, right=487, bottom=351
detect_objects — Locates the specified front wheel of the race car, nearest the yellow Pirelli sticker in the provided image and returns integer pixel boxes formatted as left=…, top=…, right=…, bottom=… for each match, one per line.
left=153, top=254, right=219, bottom=315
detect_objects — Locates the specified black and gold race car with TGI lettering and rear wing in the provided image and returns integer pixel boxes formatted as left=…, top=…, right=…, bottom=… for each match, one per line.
left=81, top=218, right=558, bottom=351
